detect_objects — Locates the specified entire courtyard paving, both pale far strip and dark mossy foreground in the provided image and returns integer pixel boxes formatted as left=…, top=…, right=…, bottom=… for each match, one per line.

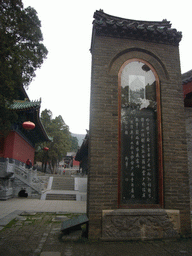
left=0, top=198, right=192, bottom=256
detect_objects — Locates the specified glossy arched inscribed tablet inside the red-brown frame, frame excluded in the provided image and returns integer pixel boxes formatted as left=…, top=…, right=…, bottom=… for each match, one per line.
left=121, top=62, right=158, bottom=204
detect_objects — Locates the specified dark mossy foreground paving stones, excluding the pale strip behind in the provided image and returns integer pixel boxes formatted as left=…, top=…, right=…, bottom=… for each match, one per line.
left=0, top=211, right=192, bottom=256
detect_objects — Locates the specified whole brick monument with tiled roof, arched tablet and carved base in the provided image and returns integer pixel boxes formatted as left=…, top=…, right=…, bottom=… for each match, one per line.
left=87, top=10, right=191, bottom=240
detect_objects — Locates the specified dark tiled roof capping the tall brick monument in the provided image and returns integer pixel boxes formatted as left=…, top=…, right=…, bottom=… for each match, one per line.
left=93, top=10, right=182, bottom=45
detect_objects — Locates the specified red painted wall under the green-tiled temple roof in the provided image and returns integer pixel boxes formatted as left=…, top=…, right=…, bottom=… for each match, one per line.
left=4, top=131, right=35, bottom=164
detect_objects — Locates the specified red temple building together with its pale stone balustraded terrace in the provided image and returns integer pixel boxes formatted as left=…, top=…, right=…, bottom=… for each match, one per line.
left=0, top=87, right=50, bottom=200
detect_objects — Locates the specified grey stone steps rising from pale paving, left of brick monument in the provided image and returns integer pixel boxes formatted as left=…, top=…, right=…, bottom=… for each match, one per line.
left=46, top=175, right=76, bottom=201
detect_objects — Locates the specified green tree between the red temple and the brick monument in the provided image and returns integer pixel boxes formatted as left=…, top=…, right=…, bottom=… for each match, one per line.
left=36, top=109, right=71, bottom=172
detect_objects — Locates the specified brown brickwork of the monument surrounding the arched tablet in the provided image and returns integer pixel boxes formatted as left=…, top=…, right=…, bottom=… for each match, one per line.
left=88, top=36, right=190, bottom=238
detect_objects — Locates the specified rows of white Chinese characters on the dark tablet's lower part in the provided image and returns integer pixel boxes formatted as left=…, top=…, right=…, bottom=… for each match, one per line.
left=121, top=108, right=157, bottom=203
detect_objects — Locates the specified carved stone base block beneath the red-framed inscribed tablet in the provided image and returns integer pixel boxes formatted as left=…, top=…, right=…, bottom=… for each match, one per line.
left=102, top=209, right=180, bottom=241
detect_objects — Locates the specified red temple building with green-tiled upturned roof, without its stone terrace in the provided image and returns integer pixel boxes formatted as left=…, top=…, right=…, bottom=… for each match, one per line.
left=0, top=87, right=49, bottom=164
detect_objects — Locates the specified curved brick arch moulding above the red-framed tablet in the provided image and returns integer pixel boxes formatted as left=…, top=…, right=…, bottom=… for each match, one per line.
left=109, top=48, right=169, bottom=80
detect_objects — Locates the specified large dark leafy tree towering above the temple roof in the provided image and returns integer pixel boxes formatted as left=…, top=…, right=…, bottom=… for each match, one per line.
left=0, top=0, right=48, bottom=133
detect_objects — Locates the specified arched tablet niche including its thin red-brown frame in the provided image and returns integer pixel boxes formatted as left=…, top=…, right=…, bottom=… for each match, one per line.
left=118, top=58, right=163, bottom=208
